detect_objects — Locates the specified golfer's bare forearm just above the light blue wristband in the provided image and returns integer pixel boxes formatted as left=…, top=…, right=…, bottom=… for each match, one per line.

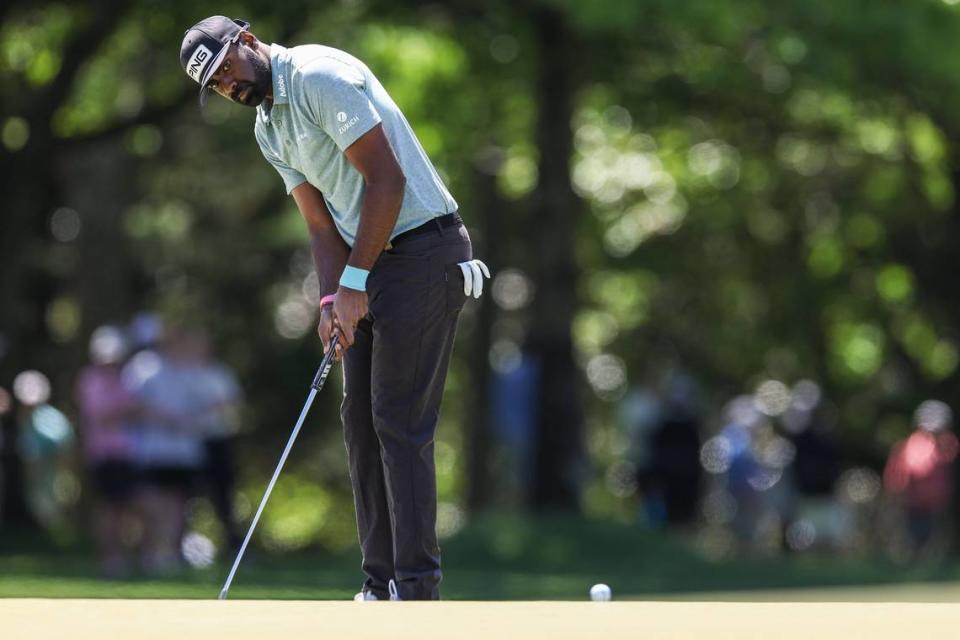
left=348, top=175, right=405, bottom=271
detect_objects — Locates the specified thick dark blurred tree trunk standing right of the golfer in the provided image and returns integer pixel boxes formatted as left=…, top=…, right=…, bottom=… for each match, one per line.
left=524, top=9, right=583, bottom=509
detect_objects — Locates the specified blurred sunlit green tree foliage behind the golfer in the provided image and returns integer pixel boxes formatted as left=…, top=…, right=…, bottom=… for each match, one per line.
left=0, top=0, right=960, bottom=540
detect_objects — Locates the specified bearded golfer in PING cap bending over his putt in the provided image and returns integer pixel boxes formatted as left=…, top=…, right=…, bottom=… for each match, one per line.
left=180, top=16, right=489, bottom=600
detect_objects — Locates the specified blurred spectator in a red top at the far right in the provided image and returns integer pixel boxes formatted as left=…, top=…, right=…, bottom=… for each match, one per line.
left=883, top=400, right=958, bottom=558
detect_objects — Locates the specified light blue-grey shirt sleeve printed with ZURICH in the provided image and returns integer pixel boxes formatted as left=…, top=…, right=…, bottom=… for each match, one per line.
left=302, top=58, right=381, bottom=151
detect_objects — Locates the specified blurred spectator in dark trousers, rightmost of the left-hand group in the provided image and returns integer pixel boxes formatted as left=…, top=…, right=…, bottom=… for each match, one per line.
left=186, top=331, right=242, bottom=549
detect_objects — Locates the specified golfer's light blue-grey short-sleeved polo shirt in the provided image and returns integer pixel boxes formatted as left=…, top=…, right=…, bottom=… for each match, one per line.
left=254, top=44, right=457, bottom=247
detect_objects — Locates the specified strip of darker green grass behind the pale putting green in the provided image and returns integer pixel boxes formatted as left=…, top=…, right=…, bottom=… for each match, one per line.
left=0, top=515, right=960, bottom=600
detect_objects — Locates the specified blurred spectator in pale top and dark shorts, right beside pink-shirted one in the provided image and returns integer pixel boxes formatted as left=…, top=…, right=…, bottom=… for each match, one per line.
left=124, top=324, right=203, bottom=574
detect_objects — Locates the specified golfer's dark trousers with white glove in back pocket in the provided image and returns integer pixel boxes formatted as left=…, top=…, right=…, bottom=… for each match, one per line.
left=341, top=225, right=472, bottom=600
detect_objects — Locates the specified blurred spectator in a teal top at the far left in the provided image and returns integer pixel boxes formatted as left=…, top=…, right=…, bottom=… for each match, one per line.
left=13, top=371, right=79, bottom=529
